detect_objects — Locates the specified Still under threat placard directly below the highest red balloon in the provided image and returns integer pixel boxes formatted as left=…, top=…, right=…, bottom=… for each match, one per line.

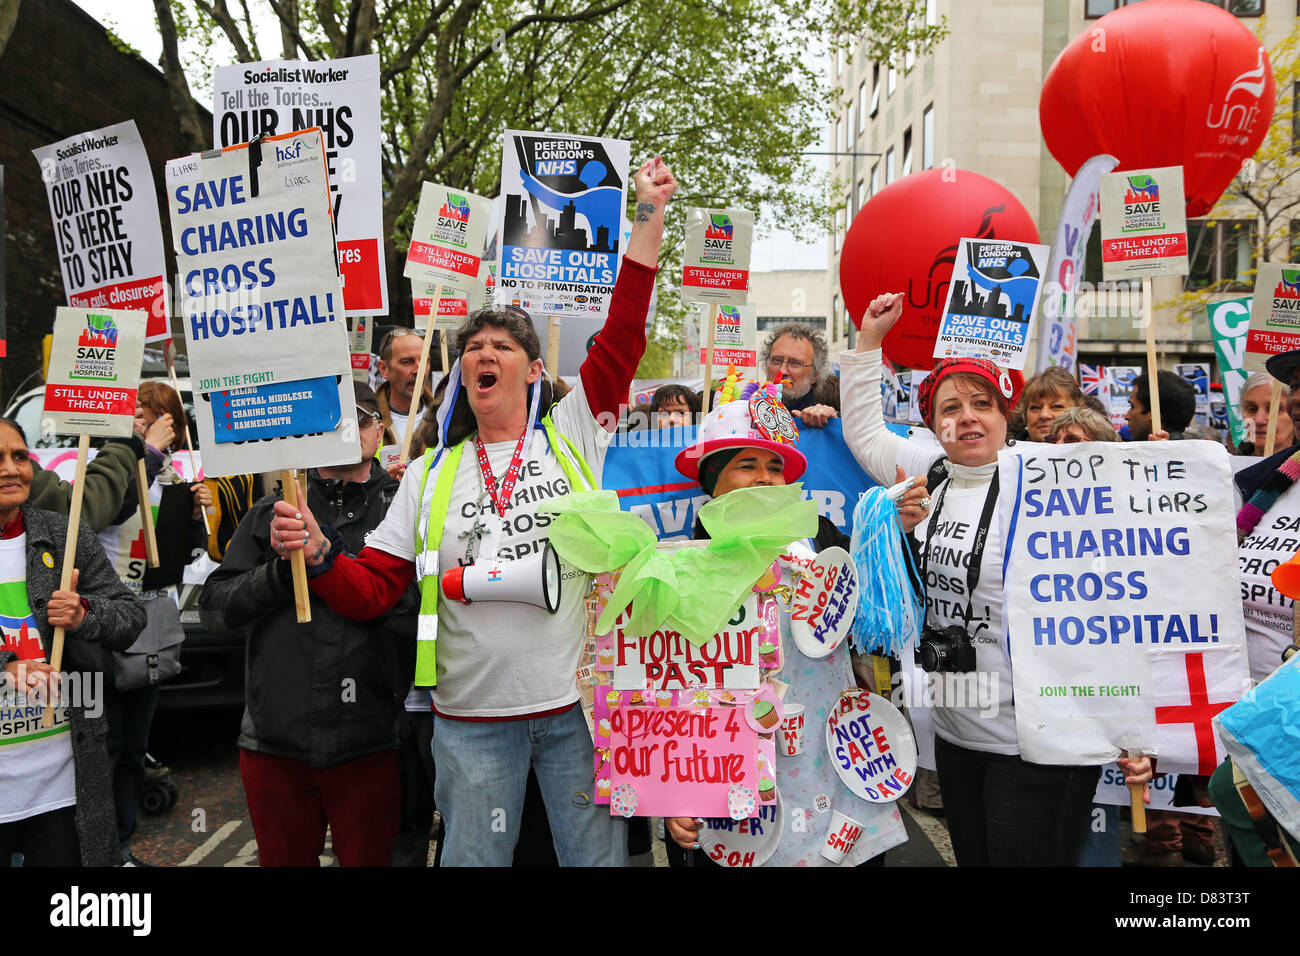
left=1101, top=166, right=1187, bottom=282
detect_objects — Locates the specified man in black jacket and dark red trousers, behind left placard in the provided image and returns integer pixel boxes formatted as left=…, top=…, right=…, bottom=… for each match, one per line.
left=202, top=382, right=419, bottom=866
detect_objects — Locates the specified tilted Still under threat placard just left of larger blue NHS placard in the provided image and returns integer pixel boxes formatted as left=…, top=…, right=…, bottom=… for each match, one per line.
left=402, top=182, right=491, bottom=298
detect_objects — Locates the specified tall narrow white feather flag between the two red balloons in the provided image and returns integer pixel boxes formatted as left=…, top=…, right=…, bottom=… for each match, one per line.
left=1037, top=153, right=1119, bottom=372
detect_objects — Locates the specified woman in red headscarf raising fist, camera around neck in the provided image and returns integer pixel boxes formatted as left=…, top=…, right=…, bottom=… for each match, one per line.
left=840, top=294, right=1151, bottom=866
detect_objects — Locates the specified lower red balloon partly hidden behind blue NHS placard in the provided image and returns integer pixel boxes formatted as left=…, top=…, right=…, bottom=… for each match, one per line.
left=840, top=169, right=1039, bottom=369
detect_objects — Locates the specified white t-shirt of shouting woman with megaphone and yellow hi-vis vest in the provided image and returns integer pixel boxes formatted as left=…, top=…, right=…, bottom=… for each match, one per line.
left=367, top=384, right=608, bottom=718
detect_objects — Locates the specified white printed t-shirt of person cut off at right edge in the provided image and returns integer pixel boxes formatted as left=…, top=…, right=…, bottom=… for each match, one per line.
left=1238, top=484, right=1300, bottom=682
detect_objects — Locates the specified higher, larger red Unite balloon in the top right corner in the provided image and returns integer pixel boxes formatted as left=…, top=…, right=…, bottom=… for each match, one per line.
left=1039, top=0, right=1274, bottom=216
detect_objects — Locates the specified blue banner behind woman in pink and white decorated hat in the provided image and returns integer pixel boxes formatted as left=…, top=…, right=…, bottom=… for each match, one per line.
left=602, top=419, right=907, bottom=541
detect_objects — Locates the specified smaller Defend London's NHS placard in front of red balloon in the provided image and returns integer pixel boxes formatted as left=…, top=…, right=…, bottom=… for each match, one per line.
left=935, top=239, right=1049, bottom=368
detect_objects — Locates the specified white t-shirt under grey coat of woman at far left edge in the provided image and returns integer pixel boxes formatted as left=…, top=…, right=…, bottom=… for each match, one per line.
left=0, top=535, right=77, bottom=823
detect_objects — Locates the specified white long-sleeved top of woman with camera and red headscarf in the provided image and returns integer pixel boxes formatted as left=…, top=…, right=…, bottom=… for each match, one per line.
left=840, top=350, right=1019, bottom=754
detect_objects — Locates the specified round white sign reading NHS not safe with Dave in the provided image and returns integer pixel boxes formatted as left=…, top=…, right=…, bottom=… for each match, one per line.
left=826, top=691, right=917, bottom=804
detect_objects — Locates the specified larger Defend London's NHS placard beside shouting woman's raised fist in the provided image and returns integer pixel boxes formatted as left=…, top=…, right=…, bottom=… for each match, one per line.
left=497, top=130, right=631, bottom=319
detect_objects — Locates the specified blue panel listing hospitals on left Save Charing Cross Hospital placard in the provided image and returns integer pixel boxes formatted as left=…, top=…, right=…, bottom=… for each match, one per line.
left=211, top=375, right=342, bottom=444
